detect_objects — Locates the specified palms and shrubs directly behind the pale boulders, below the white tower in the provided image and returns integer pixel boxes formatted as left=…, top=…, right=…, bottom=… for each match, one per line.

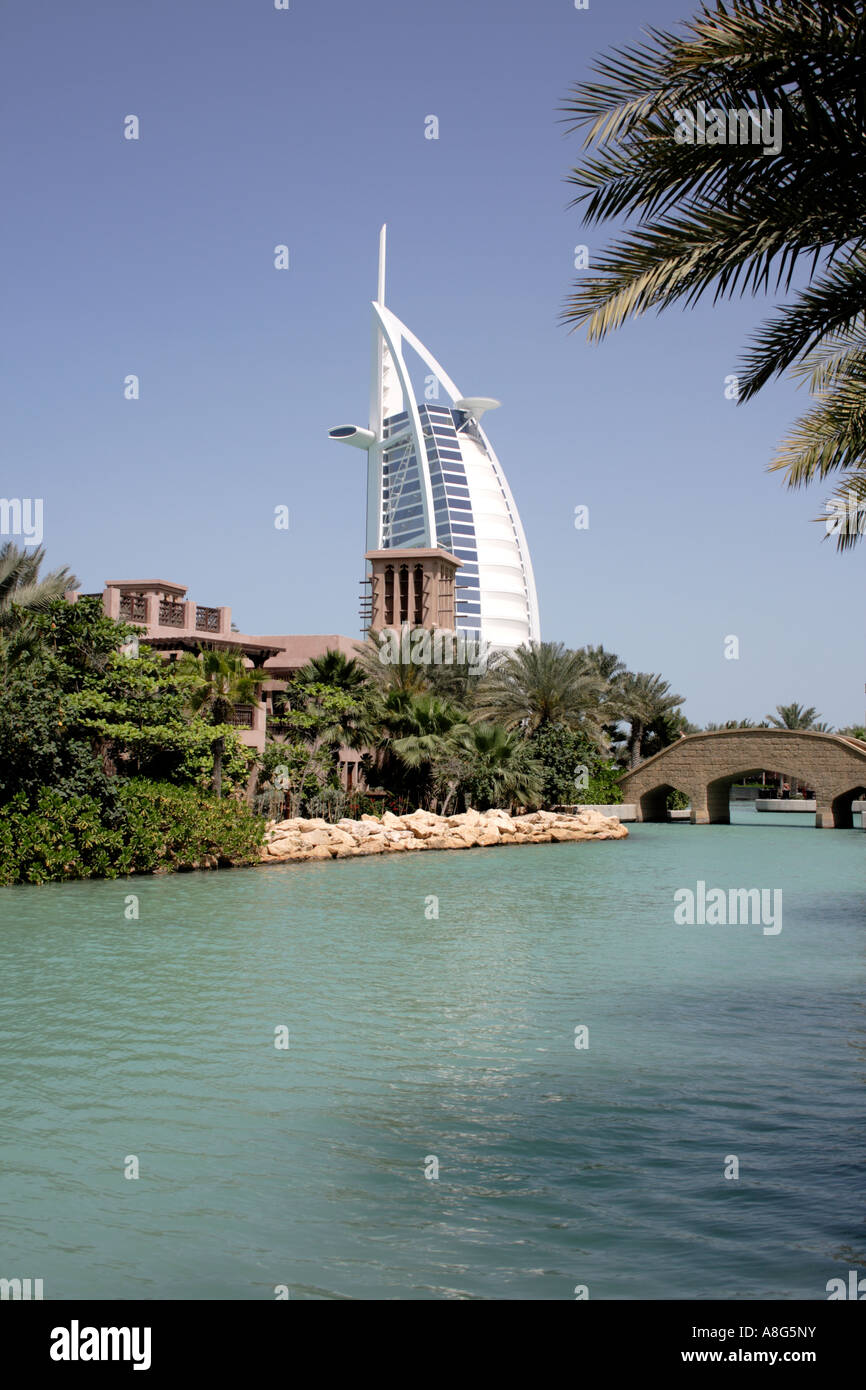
left=259, top=638, right=683, bottom=819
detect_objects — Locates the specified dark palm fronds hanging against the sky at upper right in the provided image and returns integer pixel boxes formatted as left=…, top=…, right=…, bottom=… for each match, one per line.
left=563, top=0, right=866, bottom=536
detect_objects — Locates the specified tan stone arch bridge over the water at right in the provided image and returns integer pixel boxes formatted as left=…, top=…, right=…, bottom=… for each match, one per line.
left=620, top=728, right=866, bottom=830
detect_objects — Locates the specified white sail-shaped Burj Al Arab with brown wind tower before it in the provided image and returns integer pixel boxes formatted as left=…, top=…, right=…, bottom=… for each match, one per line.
left=329, top=227, right=539, bottom=648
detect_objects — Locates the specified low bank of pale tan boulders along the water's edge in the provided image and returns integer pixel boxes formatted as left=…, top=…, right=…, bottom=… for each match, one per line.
left=261, top=810, right=628, bottom=863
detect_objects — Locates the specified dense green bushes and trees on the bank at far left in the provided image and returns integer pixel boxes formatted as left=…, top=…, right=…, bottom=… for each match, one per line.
left=0, top=561, right=264, bottom=883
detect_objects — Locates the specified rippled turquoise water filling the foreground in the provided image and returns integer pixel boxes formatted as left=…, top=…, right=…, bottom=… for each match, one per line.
left=0, top=810, right=866, bottom=1300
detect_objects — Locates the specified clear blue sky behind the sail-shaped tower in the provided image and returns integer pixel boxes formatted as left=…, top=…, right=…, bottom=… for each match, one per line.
left=0, top=0, right=866, bottom=724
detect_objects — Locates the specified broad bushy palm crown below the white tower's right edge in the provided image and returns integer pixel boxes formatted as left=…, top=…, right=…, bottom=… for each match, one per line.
left=473, top=642, right=605, bottom=744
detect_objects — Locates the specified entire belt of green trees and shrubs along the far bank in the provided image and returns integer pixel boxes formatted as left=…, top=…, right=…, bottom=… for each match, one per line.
left=0, top=546, right=866, bottom=884
